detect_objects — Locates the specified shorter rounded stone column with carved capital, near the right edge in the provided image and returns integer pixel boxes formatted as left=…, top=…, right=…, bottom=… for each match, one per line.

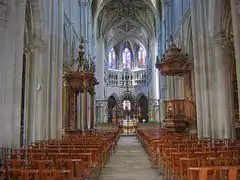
left=214, top=34, right=233, bottom=139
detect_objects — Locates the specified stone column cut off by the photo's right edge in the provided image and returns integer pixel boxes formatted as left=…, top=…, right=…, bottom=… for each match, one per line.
left=230, top=0, right=240, bottom=119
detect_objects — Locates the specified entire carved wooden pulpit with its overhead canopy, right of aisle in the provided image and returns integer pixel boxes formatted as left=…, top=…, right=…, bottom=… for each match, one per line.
left=156, top=37, right=196, bottom=132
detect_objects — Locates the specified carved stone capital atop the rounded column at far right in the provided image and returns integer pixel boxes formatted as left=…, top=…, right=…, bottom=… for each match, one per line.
left=213, top=32, right=233, bottom=49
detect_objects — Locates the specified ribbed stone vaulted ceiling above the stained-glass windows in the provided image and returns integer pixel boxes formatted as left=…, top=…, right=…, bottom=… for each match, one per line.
left=93, top=0, right=159, bottom=48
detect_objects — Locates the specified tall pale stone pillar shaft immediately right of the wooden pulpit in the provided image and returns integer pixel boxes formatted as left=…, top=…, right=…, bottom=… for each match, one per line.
left=191, top=0, right=209, bottom=138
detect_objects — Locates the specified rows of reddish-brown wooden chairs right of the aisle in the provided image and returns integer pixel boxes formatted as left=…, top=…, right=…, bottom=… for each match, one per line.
left=137, top=129, right=240, bottom=180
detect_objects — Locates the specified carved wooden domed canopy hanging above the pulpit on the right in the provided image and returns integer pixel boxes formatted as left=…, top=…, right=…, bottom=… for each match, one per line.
left=156, top=36, right=190, bottom=76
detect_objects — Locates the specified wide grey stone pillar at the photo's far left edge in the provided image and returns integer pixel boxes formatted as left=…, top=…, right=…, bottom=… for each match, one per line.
left=0, top=1, right=25, bottom=148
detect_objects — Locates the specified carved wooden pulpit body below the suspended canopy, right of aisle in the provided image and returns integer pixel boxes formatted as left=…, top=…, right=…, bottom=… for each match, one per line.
left=164, top=100, right=196, bottom=132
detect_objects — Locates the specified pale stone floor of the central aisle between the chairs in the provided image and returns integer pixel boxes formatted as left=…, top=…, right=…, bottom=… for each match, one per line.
left=100, top=136, right=162, bottom=180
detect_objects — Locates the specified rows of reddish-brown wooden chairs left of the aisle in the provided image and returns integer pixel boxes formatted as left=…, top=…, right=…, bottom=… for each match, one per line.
left=0, top=130, right=120, bottom=180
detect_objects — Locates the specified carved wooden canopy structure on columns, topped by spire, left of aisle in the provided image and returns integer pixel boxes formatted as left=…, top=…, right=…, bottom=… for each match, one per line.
left=63, top=39, right=98, bottom=131
